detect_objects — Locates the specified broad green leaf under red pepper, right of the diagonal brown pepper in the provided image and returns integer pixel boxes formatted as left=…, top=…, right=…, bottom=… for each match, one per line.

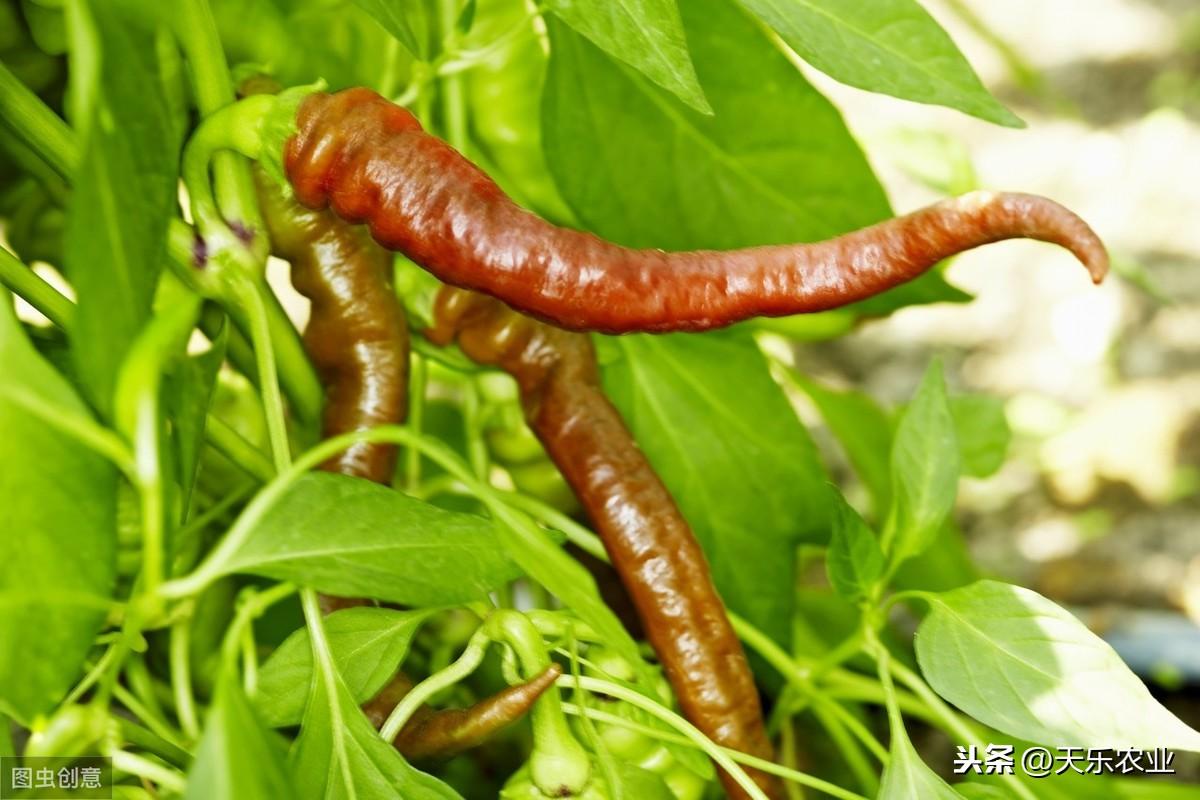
left=604, top=331, right=829, bottom=642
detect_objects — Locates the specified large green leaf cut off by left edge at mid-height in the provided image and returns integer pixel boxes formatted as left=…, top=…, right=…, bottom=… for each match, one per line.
left=0, top=289, right=116, bottom=726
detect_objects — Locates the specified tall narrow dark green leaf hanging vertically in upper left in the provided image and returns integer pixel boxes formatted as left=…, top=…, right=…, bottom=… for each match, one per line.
left=64, top=0, right=179, bottom=413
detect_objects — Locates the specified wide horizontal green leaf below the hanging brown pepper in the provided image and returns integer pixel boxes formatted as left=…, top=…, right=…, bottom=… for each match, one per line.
left=224, top=473, right=520, bottom=607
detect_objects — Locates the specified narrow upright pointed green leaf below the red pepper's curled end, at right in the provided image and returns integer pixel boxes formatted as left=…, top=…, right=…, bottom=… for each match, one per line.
left=888, top=359, right=959, bottom=561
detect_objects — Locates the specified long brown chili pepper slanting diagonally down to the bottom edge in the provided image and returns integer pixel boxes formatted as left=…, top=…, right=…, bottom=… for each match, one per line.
left=428, top=288, right=780, bottom=798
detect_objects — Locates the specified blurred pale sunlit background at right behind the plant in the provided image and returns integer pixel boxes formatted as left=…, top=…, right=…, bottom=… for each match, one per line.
left=797, top=0, right=1200, bottom=772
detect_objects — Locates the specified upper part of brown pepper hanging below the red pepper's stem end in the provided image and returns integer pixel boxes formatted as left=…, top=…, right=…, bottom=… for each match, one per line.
left=256, top=170, right=409, bottom=486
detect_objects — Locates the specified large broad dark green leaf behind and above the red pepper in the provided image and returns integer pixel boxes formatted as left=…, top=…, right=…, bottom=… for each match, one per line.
left=542, top=0, right=961, bottom=314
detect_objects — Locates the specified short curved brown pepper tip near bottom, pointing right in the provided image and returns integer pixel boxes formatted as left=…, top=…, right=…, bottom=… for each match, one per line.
left=362, top=663, right=563, bottom=760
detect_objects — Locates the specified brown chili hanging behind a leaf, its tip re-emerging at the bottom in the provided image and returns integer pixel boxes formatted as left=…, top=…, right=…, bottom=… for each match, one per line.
left=256, top=158, right=562, bottom=758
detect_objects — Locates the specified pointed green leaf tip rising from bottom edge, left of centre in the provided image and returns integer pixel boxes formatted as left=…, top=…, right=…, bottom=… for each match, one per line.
left=184, top=675, right=296, bottom=800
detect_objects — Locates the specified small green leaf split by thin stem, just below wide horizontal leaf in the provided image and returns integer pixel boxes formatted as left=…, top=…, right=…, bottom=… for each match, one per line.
left=254, top=607, right=437, bottom=727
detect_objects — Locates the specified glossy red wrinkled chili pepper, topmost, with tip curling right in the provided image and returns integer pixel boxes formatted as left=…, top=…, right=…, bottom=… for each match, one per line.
left=283, top=89, right=1109, bottom=333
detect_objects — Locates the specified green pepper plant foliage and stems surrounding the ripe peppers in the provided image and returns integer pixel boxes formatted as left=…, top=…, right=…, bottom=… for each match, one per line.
left=0, top=0, right=1200, bottom=800
